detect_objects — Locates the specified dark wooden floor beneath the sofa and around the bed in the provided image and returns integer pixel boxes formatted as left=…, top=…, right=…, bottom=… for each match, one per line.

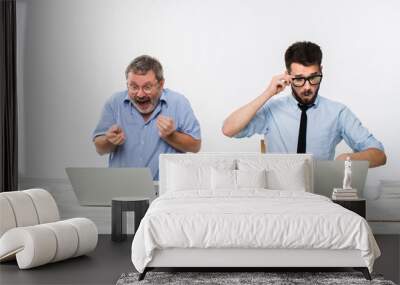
left=0, top=235, right=400, bottom=285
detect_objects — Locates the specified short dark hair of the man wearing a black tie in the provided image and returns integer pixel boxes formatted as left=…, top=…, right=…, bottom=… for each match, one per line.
left=285, top=42, right=322, bottom=71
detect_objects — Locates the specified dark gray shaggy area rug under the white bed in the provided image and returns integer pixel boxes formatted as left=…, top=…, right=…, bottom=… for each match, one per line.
left=117, top=272, right=395, bottom=285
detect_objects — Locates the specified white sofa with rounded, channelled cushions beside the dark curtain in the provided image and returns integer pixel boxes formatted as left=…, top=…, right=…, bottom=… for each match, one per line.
left=0, top=189, right=98, bottom=269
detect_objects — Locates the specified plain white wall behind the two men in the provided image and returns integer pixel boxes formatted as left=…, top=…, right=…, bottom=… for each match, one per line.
left=17, top=0, right=400, bottom=191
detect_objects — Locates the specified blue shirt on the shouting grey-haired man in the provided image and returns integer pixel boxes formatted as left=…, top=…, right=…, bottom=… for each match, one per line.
left=93, top=89, right=201, bottom=180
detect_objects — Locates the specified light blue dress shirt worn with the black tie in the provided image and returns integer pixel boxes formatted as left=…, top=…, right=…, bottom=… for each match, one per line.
left=235, top=95, right=384, bottom=160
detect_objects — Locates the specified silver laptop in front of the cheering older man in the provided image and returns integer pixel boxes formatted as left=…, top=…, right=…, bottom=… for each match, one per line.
left=65, top=167, right=155, bottom=206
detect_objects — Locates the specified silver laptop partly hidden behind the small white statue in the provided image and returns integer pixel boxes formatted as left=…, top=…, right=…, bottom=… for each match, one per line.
left=314, top=160, right=369, bottom=197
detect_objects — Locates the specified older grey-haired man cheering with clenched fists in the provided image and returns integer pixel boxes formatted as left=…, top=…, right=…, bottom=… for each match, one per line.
left=93, top=55, right=201, bottom=180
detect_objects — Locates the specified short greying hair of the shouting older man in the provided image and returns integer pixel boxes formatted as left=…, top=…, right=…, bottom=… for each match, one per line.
left=125, top=55, right=164, bottom=81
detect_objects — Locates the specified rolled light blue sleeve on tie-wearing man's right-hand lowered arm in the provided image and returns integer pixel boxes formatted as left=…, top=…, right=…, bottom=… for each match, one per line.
left=339, top=107, right=384, bottom=152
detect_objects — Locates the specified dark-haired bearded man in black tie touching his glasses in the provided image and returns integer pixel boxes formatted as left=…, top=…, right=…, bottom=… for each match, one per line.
left=222, top=42, right=386, bottom=167
